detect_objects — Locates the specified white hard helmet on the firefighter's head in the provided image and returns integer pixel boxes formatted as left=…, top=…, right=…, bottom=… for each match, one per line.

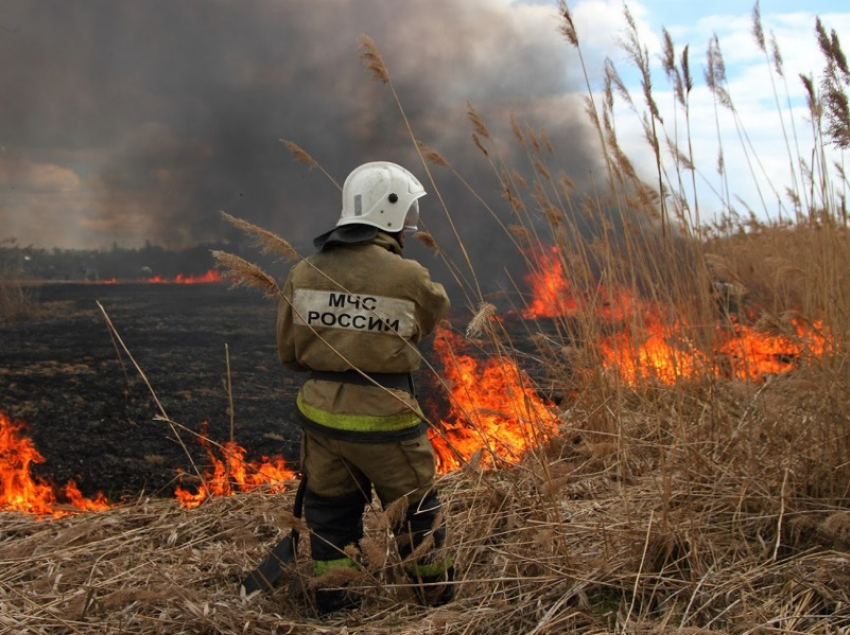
left=336, top=161, right=425, bottom=234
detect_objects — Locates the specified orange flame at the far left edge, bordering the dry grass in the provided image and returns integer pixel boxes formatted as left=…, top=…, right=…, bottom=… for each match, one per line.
left=0, top=412, right=110, bottom=517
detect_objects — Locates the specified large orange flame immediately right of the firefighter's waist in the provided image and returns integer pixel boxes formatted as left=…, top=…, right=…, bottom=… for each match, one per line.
left=429, top=328, right=557, bottom=474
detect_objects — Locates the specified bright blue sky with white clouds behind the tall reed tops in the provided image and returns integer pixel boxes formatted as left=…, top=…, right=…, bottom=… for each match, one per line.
left=534, top=0, right=850, bottom=225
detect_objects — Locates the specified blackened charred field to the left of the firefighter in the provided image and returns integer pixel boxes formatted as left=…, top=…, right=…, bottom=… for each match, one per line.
left=0, top=283, right=300, bottom=501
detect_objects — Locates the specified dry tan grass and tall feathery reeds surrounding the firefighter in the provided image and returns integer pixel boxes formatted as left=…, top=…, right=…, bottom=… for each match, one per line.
left=0, top=3, right=850, bottom=635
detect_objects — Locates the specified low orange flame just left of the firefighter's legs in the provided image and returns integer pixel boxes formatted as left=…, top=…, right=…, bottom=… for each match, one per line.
left=174, top=422, right=296, bottom=509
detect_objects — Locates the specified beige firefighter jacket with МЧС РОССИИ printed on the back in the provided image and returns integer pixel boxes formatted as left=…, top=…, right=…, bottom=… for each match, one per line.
left=277, top=233, right=449, bottom=433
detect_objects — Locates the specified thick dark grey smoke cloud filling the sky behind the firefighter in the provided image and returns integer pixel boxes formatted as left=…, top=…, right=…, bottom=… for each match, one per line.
left=0, top=0, right=595, bottom=300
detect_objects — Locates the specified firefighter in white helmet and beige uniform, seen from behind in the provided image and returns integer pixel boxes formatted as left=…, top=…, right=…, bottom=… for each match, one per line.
left=277, top=161, right=454, bottom=614
